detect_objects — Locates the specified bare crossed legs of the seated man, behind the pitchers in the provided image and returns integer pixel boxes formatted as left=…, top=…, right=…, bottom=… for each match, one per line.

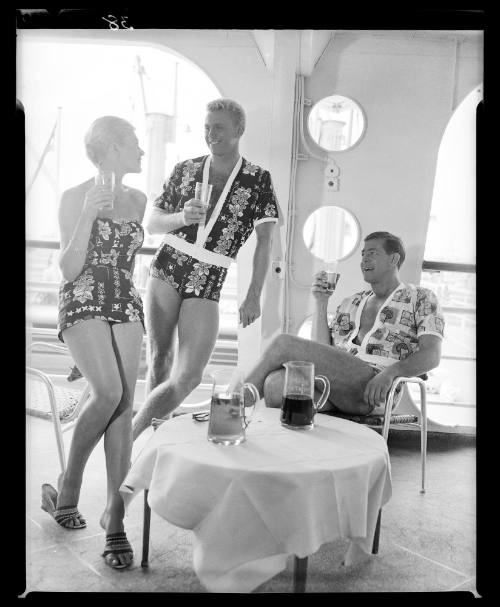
left=246, top=333, right=375, bottom=415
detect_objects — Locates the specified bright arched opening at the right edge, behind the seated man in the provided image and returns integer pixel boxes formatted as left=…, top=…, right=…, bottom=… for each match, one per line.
left=421, top=86, right=483, bottom=426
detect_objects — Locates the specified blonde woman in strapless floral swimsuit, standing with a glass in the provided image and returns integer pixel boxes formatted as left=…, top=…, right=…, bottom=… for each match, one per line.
left=42, top=116, right=146, bottom=569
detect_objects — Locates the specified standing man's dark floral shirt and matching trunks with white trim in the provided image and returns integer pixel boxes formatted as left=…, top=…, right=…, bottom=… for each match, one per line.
left=150, top=156, right=278, bottom=302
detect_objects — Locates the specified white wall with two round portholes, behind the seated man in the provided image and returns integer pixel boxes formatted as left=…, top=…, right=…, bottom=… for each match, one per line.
left=291, top=33, right=482, bottom=332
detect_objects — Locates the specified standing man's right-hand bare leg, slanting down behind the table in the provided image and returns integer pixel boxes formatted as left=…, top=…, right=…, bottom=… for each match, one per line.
left=133, top=297, right=219, bottom=440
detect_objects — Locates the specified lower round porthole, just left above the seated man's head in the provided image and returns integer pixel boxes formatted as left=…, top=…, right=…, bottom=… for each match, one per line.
left=302, top=206, right=361, bottom=263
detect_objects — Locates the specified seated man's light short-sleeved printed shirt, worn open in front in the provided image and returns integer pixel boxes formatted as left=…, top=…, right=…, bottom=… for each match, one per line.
left=330, top=283, right=444, bottom=366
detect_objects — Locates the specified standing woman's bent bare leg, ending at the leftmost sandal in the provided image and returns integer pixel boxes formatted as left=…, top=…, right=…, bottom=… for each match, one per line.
left=57, top=319, right=123, bottom=508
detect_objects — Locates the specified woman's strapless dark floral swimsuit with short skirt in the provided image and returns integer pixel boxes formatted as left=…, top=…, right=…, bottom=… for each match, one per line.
left=58, top=217, right=144, bottom=341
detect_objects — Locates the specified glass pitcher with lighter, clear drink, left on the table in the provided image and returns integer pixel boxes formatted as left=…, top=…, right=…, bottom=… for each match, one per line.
left=208, top=369, right=259, bottom=445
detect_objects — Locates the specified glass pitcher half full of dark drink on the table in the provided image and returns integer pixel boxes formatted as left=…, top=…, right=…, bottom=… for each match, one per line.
left=281, top=360, right=330, bottom=430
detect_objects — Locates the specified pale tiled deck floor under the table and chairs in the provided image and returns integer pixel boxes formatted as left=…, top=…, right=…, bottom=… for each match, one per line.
left=26, top=416, right=476, bottom=593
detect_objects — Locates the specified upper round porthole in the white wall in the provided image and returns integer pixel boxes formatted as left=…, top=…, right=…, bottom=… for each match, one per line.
left=307, top=95, right=366, bottom=152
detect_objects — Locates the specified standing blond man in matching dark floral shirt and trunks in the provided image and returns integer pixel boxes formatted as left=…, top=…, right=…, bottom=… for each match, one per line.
left=133, top=99, right=278, bottom=440
